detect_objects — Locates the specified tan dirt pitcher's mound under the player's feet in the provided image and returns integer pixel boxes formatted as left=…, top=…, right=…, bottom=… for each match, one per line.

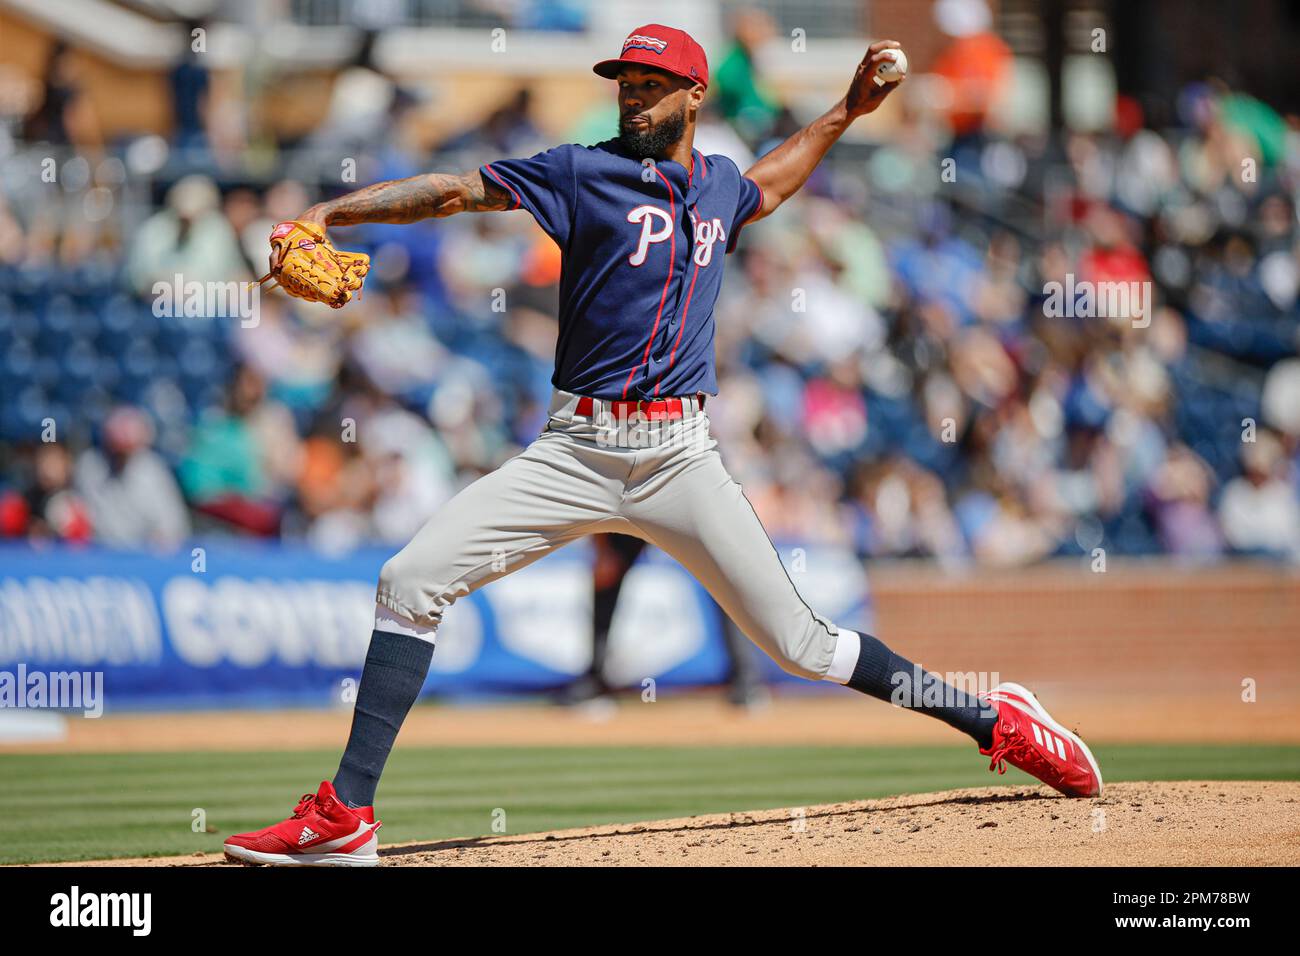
left=48, top=780, right=1300, bottom=866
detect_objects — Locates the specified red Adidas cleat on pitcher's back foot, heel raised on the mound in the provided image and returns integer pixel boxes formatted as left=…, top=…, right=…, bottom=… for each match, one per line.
left=980, top=683, right=1101, bottom=797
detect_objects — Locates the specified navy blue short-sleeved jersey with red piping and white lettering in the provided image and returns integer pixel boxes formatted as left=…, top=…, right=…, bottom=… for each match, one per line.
left=481, top=140, right=763, bottom=399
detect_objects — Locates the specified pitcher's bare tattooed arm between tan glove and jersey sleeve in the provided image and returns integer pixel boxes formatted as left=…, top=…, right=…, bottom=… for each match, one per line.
left=321, top=170, right=510, bottom=226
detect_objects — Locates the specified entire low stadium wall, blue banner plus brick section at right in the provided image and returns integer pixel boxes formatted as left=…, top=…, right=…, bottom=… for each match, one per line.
left=0, top=542, right=1300, bottom=713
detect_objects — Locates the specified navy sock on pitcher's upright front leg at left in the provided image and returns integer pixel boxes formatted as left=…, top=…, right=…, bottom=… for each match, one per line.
left=334, top=631, right=433, bottom=806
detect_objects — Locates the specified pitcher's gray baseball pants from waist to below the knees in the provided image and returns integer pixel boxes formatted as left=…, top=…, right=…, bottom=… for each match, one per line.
left=376, top=390, right=858, bottom=684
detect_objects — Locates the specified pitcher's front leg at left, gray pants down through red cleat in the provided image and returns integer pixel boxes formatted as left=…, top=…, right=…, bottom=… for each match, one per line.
left=225, top=432, right=627, bottom=866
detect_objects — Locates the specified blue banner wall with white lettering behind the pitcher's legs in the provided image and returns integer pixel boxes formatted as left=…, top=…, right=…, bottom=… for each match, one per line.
left=0, top=542, right=871, bottom=710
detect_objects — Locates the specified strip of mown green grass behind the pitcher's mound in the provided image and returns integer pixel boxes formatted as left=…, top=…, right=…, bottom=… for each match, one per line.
left=0, top=745, right=1300, bottom=864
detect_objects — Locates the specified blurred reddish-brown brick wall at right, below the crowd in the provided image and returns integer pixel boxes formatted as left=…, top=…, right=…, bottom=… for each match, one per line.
left=870, top=562, right=1300, bottom=701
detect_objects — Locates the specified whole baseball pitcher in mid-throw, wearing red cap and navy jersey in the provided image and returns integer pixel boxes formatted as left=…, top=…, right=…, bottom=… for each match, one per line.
left=225, top=23, right=1101, bottom=866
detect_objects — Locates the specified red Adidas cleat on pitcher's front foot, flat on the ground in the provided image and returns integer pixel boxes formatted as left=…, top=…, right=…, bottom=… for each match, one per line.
left=225, top=780, right=384, bottom=866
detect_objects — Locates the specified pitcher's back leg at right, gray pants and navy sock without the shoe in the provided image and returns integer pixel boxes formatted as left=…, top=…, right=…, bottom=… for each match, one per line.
left=624, top=450, right=996, bottom=747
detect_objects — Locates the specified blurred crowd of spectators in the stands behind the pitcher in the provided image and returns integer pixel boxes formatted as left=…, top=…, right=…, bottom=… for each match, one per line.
left=0, top=7, right=1300, bottom=566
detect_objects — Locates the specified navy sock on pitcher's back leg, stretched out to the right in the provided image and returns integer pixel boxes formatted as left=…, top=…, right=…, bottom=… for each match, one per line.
left=849, top=633, right=997, bottom=749
